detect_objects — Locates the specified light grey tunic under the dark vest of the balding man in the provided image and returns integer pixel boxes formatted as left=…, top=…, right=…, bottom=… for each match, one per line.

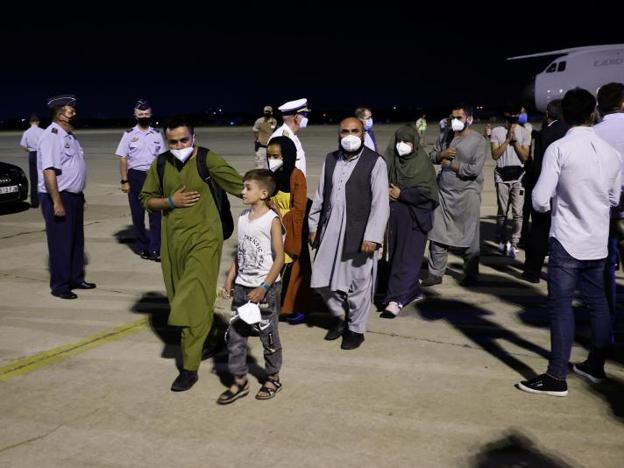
left=308, top=155, right=390, bottom=293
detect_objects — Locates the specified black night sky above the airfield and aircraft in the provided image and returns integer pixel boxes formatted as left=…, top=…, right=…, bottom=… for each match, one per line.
left=0, top=0, right=624, bottom=121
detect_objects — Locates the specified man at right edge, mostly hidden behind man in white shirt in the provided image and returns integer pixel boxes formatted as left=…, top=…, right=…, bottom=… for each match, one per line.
left=594, top=83, right=624, bottom=319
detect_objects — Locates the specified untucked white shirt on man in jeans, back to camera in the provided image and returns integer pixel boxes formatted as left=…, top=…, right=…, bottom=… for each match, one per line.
left=533, top=127, right=622, bottom=260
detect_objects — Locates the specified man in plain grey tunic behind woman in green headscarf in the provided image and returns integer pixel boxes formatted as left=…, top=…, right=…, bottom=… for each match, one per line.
left=422, top=105, right=490, bottom=286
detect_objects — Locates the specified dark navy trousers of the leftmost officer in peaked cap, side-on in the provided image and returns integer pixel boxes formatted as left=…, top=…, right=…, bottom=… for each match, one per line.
left=39, top=192, right=84, bottom=294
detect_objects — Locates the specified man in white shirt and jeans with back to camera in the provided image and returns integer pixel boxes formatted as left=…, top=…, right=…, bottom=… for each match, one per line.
left=518, top=88, right=622, bottom=396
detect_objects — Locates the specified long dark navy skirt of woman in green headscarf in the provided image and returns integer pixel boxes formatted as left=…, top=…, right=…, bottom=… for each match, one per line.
left=384, top=202, right=427, bottom=305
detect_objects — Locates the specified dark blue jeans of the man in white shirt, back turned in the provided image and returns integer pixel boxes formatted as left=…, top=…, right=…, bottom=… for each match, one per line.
left=548, top=238, right=611, bottom=379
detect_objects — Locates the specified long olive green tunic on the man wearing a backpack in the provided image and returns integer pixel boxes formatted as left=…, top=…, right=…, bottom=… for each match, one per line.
left=140, top=151, right=243, bottom=328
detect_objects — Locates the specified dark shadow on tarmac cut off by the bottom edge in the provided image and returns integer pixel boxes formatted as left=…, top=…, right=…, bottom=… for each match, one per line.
left=469, top=430, right=572, bottom=468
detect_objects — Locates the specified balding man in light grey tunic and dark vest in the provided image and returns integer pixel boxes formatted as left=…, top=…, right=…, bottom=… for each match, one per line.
left=308, top=117, right=390, bottom=349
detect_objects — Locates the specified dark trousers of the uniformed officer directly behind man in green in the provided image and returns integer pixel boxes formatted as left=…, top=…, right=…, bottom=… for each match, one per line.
left=128, top=169, right=161, bottom=253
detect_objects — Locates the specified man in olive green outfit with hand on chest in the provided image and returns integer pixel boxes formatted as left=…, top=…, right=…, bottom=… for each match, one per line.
left=140, top=119, right=243, bottom=391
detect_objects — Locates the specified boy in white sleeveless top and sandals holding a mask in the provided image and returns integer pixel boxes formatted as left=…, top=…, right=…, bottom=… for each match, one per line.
left=217, top=169, right=284, bottom=405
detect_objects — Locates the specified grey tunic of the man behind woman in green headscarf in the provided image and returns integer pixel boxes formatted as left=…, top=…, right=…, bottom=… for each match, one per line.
left=428, top=131, right=490, bottom=247
